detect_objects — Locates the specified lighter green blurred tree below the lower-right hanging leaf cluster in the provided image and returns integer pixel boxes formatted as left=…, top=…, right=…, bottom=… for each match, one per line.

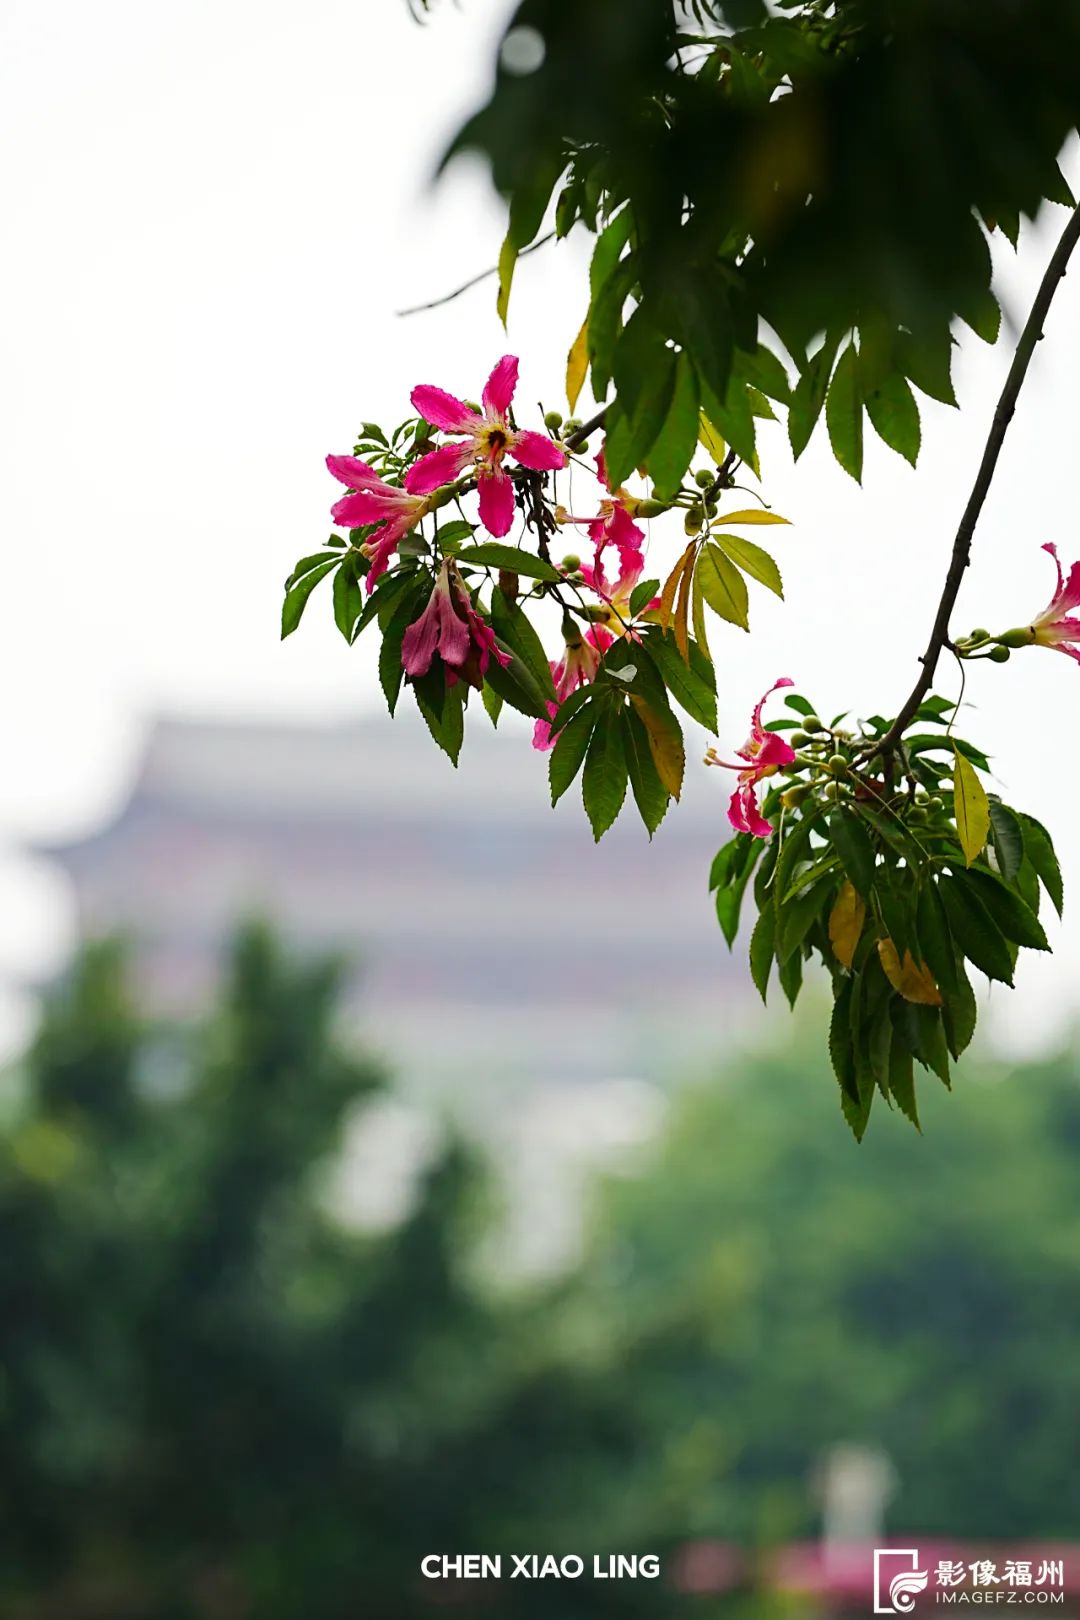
left=576, top=1023, right=1080, bottom=1545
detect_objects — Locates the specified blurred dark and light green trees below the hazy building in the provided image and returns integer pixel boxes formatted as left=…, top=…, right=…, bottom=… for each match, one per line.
left=0, top=932, right=1080, bottom=1620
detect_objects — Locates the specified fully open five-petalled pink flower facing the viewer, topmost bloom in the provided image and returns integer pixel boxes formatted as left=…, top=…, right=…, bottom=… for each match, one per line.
left=405, top=355, right=567, bottom=538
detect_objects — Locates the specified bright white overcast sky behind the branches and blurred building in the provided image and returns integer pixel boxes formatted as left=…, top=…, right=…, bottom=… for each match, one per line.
left=0, top=0, right=1080, bottom=1043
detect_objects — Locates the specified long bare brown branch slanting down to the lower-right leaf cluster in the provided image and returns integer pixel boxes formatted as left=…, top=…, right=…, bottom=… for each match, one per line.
left=870, top=207, right=1080, bottom=758
